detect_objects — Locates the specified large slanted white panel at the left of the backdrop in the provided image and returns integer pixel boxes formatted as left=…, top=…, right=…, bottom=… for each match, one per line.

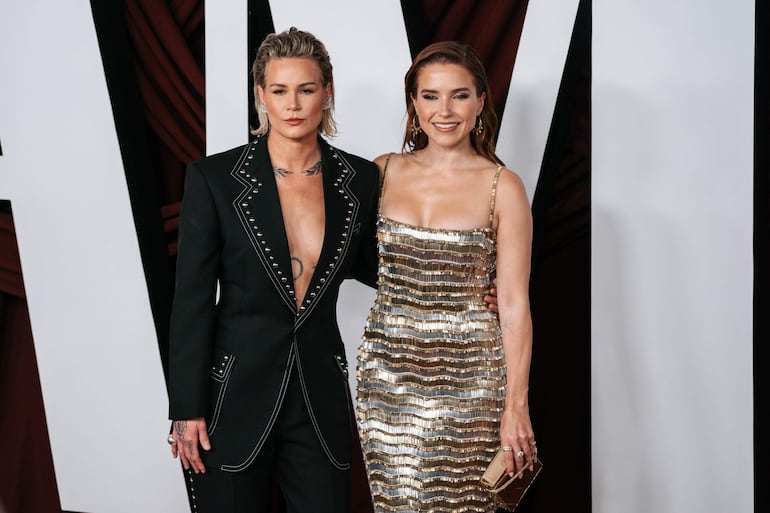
left=0, top=0, right=186, bottom=513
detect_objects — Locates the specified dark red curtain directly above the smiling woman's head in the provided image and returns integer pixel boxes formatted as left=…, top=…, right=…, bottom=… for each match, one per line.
left=401, top=0, right=527, bottom=119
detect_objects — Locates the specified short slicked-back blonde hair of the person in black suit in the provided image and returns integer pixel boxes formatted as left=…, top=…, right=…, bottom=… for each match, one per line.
left=251, top=27, right=337, bottom=137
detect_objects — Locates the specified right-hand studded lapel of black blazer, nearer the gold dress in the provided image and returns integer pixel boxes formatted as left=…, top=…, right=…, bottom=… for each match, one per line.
left=296, top=140, right=360, bottom=328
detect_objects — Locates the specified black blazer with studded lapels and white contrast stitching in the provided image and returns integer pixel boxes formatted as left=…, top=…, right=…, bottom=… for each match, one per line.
left=169, top=137, right=379, bottom=472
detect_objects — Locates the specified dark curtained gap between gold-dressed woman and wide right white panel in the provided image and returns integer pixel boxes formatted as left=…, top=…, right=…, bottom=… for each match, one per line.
left=522, top=0, right=591, bottom=513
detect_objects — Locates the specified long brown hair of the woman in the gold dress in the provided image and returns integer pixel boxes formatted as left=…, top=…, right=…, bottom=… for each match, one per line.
left=403, top=41, right=503, bottom=165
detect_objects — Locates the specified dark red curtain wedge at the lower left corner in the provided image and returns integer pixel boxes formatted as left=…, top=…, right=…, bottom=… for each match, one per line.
left=0, top=201, right=61, bottom=513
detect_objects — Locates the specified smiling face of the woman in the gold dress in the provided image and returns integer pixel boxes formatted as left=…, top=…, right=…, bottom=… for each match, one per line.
left=412, top=63, right=484, bottom=147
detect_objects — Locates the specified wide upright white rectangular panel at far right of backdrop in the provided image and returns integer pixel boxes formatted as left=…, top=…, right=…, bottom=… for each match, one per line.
left=591, top=0, right=752, bottom=513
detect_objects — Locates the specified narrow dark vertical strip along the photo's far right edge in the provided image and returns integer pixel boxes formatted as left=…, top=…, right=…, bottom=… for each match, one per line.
left=753, top=0, right=770, bottom=511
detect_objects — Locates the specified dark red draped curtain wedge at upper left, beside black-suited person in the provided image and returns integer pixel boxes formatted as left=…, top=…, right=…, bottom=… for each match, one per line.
left=124, top=0, right=206, bottom=255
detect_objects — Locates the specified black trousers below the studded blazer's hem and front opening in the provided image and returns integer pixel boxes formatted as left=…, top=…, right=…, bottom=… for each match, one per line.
left=185, top=369, right=350, bottom=513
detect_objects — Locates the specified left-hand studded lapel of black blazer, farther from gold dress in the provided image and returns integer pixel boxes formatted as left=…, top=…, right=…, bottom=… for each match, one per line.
left=230, top=137, right=296, bottom=312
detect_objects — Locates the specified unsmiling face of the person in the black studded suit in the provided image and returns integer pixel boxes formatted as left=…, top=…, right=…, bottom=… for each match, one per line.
left=256, top=57, right=331, bottom=142
